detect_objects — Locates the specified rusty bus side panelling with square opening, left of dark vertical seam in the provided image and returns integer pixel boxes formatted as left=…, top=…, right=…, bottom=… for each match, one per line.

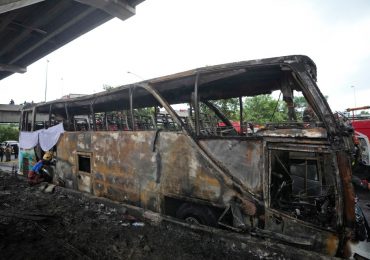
left=57, top=131, right=160, bottom=211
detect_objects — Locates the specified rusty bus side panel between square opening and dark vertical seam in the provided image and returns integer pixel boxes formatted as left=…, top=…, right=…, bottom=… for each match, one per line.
left=92, top=131, right=159, bottom=211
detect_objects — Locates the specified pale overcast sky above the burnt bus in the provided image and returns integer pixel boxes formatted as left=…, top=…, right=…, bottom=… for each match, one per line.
left=0, top=0, right=370, bottom=110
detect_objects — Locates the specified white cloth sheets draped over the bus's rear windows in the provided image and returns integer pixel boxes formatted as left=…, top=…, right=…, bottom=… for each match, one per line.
left=19, top=123, right=64, bottom=151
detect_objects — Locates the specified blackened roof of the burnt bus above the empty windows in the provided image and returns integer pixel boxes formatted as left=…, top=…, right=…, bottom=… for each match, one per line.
left=30, top=55, right=316, bottom=114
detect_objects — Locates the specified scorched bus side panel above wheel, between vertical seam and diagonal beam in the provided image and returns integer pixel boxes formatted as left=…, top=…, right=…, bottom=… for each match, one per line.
left=157, top=133, right=231, bottom=205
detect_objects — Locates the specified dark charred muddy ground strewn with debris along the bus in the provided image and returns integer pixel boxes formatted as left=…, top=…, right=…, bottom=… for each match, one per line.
left=0, top=171, right=346, bottom=259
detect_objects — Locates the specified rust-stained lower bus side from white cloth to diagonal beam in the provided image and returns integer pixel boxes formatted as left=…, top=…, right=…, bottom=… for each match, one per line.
left=57, top=131, right=240, bottom=211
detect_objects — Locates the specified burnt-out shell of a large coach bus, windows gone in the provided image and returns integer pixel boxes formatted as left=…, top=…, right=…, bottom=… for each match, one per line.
left=21, top=55, right=355, bottom=256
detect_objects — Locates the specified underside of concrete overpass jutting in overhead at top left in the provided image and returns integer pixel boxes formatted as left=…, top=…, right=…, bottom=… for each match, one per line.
left=0, top=0, right=144, bottom=80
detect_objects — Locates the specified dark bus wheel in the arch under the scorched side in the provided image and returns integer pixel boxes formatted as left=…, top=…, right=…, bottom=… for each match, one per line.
left=176, top=203, right=217, bottom=227
